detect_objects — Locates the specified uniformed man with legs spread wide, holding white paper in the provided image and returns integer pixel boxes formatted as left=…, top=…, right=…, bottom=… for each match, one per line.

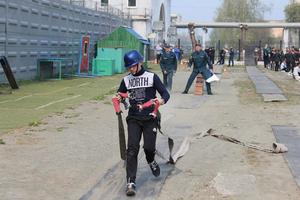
left=182, top=44, right=213, bottom=95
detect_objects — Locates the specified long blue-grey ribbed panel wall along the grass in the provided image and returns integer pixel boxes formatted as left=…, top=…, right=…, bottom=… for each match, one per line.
left=0, top=0, right=130, bottom=82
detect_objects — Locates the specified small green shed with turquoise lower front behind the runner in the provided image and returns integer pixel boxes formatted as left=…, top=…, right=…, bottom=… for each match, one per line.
left=93, top=26, right=150, bottom=75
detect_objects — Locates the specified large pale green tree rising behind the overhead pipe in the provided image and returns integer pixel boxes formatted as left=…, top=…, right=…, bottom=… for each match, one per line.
left=210, top=0, right=271, bottom=48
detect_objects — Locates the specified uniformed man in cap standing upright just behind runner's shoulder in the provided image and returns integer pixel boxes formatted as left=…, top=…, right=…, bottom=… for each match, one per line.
left=160, top=45, right=177, bottom=91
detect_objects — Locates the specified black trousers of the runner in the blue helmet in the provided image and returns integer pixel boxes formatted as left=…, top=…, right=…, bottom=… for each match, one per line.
left=126, top=116, right=157, bottom=181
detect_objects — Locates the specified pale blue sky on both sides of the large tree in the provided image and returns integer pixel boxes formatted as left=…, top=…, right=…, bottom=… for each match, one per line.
left=171, top=0, right=289, bottom=23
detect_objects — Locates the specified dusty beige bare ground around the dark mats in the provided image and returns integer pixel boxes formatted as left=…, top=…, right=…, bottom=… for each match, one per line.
left=0, top=65, right=300, bottom=200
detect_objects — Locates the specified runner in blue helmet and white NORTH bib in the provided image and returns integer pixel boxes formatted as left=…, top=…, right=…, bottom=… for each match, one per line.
left=118, top=50, right=170, bottom=196
